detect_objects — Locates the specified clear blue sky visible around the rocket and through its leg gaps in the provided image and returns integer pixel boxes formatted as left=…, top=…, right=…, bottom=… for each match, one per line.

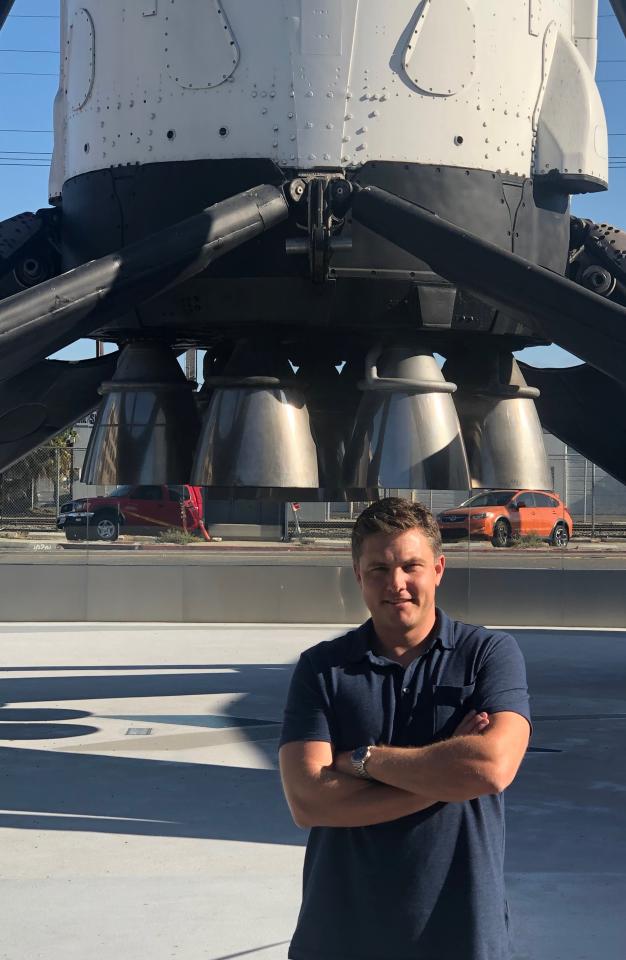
left=0, top=0, right=626, bottom=366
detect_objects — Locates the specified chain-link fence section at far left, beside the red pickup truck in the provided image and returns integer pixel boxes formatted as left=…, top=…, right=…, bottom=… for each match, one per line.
left=0, top=444, right=74, bottom=530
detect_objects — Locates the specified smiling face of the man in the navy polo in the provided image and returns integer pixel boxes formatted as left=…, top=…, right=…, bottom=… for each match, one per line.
left=354, top=527, right=445, bottom=635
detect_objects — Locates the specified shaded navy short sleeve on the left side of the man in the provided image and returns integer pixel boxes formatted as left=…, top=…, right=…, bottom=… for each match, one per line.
left=280, top=652, right=332, bottom=747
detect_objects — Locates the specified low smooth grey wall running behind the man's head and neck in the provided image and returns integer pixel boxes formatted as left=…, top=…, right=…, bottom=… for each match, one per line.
left=0, top=557, right=626, bottom=628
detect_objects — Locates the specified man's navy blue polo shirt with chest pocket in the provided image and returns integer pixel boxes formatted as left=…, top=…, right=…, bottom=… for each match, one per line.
left=281, top=610, right=530, bottom=960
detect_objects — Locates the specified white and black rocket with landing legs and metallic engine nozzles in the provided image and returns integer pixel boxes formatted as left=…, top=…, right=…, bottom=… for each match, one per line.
left=0, top=0, right=626, bottom=500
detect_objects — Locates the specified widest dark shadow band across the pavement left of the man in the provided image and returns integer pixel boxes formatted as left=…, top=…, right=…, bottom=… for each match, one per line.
left=0, top=744, right=305, bottom=845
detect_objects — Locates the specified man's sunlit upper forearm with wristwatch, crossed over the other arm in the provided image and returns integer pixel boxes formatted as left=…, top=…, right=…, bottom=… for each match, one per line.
left=367, top=736, right=503, bottom=802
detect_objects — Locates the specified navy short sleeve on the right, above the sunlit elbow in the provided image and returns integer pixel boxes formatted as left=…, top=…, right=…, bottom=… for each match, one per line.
left=472, top=633, right=532, bottom=728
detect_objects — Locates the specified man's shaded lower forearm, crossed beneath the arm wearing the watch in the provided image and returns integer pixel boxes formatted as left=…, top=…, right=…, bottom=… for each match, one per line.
left=292, top=767, right=434, bottom=827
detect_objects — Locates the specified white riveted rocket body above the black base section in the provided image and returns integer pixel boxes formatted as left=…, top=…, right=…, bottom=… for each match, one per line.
left=50, top=0, right=608, bottom=199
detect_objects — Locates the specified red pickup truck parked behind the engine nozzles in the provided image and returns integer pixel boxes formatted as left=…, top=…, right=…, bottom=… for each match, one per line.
left=57, top=484, right=203, bottom=542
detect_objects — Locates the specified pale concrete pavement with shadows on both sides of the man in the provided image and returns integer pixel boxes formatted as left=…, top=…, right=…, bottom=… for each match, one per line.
left=0, top=624, right=626, bottom=960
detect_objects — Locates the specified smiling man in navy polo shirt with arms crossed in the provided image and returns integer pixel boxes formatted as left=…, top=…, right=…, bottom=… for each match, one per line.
left=280, top=498, right=530, bottom=960
